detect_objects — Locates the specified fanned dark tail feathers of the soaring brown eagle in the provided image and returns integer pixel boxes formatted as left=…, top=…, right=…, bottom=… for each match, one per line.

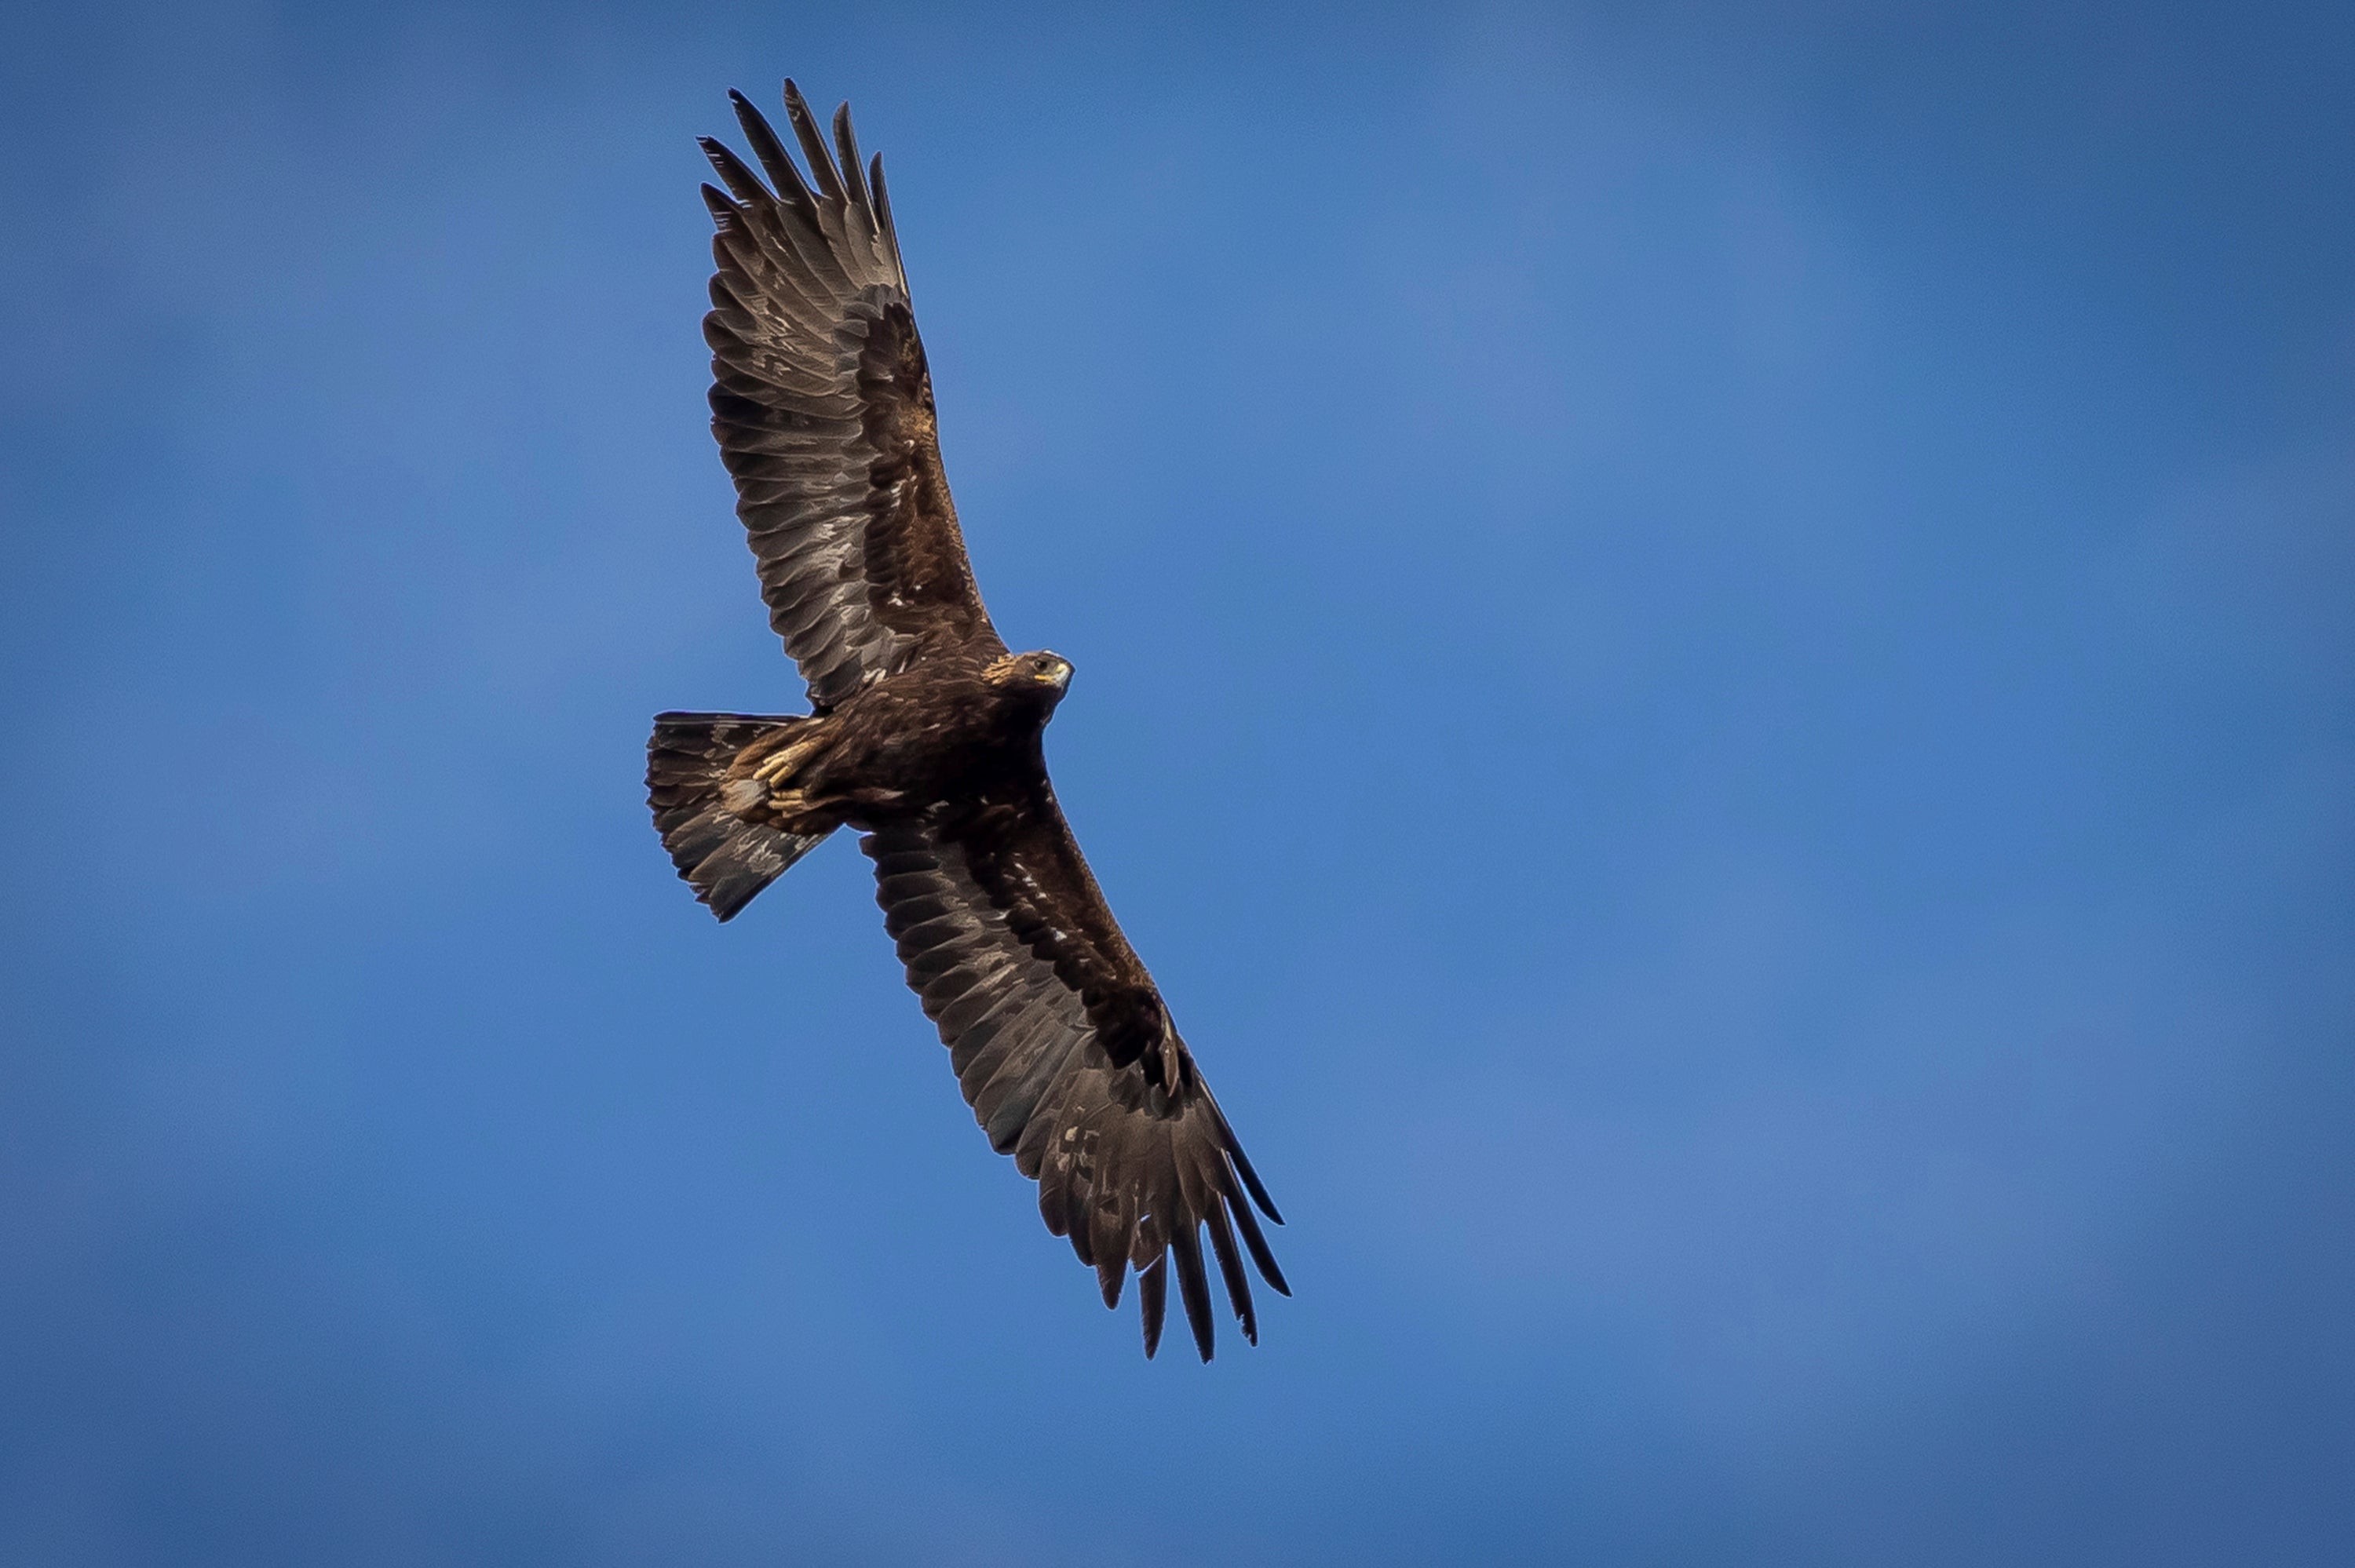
left=645, top=713, right=824, bottom=921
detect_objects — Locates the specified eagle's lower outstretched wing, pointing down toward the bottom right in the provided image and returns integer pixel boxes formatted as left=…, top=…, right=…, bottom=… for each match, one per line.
left=864, top=796, right=1291, bottom=1361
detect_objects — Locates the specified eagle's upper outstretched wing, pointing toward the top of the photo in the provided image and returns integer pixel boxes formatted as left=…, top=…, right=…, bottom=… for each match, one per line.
left=702, top=82, right=1003, bottom=709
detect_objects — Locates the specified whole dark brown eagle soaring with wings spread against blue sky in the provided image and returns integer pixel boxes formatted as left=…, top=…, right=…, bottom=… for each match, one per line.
left=645, top=82, right=1291, bottom=1361
